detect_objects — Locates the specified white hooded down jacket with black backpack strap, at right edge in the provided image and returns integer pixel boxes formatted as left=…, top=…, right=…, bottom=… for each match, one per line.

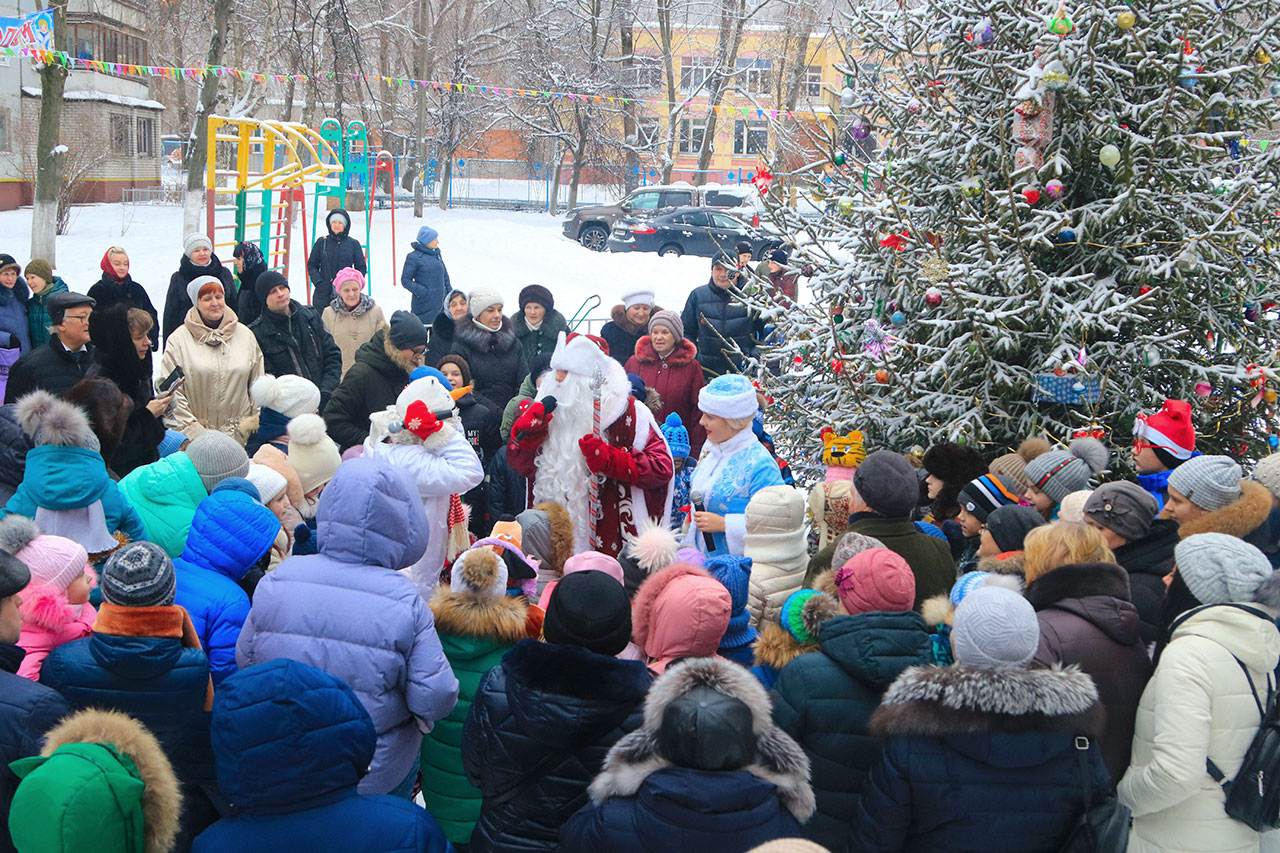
left=1119, top=605, right=1280, bottom=853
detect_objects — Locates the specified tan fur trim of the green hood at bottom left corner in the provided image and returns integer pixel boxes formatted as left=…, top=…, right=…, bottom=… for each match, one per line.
left=40, top=708, right=182, bottom=853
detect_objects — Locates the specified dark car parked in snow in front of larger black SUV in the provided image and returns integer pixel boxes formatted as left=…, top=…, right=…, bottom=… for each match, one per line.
left=608, top=207, right=782, bottom=260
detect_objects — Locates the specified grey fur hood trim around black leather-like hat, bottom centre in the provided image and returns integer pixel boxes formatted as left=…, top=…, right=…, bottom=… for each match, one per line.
left=589, top=657, right=814, bottom=822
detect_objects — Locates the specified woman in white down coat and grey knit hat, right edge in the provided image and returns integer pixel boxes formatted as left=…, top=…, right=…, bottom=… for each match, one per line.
left=1117, top=533, right=1280, bottom=853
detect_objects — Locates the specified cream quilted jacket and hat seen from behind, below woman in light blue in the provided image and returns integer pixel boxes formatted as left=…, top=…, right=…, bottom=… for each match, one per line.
left=742, top=485, right=809, bottom=628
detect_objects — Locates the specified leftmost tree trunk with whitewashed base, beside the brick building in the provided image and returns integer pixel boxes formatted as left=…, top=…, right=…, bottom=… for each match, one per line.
left=31, top=0, right=68, bottom=266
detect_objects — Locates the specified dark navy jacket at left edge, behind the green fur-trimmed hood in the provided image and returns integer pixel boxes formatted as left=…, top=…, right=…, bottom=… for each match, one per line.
left=0, top=643, right=70, bottom=853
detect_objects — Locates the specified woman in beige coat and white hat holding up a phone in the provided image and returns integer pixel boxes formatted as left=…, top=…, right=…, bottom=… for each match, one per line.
left=160, top=275, right=262, bottom=443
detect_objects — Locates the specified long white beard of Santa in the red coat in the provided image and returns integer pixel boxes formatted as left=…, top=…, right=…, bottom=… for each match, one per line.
left=534, top=373, right=593, bottom=545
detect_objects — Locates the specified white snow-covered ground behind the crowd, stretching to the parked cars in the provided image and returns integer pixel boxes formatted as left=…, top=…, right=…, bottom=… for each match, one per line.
left=0, top=204, right=710, bottom=330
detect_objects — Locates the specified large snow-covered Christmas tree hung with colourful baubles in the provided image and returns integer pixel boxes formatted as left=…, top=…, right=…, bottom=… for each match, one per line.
left=760, top=0, right=1280, bottom=460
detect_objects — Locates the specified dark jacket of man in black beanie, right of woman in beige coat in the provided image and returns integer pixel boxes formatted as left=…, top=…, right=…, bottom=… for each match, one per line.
left=248, top=300, right=342, bottom=397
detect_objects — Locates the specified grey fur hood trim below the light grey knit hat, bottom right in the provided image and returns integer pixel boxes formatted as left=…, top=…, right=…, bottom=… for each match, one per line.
left=870, top=666, right=1105, bottom=738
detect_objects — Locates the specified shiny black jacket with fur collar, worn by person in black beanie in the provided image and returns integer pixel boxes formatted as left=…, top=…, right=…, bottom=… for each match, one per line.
left=462, top=640, right=652, bottom=853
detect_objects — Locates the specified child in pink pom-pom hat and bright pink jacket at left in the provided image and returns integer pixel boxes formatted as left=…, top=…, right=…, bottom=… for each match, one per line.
left=0, top=515, right=97, bottom=681
